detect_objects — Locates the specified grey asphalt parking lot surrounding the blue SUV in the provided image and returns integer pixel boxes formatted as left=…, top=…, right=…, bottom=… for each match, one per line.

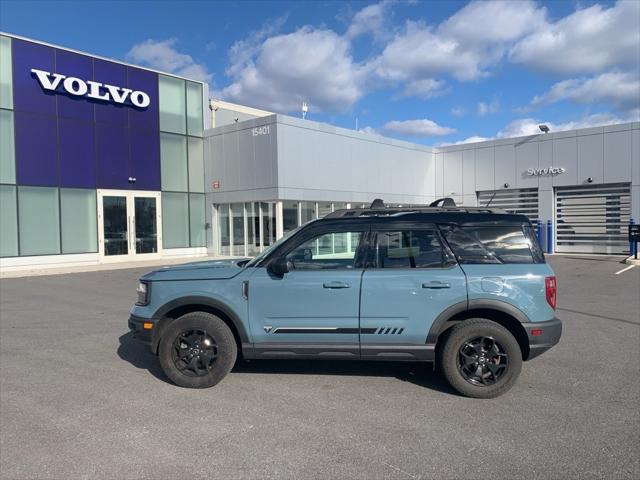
left=0, top=256, right=640, bottom=479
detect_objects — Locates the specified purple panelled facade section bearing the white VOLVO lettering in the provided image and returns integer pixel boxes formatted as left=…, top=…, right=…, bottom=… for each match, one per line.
left=12, top=39, right=160, bottom=190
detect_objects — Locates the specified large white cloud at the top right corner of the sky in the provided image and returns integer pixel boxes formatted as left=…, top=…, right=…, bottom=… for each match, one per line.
left=511, top=0, right=640, bottom=74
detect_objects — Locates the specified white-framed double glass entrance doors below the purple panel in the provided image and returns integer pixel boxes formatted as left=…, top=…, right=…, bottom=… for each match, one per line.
left=98, top=190, right=162, bottom=262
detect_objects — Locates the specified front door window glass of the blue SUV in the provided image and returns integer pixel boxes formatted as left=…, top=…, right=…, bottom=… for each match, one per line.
left=287, top=232, right=363, bottom=270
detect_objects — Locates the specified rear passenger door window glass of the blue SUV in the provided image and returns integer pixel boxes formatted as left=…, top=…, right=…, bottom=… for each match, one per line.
left=376, top=230, right=453, bottom=268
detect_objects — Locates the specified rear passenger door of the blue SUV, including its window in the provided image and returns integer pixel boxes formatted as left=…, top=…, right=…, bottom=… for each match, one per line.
left=360, top=224, right=467, bottom=360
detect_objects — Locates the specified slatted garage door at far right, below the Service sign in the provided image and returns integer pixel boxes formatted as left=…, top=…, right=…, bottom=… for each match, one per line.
left=556, top=183, right=631, bottom=254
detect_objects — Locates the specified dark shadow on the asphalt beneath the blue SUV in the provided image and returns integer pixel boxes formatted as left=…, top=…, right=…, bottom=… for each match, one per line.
left=118, top=332, right=457, bottom=395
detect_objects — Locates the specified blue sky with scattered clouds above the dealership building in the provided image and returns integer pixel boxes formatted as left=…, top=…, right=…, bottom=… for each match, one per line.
left=0, top=0, right=640, bottom=146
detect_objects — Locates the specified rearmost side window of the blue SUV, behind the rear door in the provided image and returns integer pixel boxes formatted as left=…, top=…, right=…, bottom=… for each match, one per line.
left=442, top=225, right=544, bottom=264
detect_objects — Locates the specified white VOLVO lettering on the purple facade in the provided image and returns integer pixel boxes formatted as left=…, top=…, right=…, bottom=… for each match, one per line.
left=31, top=68, right=151, bottom=108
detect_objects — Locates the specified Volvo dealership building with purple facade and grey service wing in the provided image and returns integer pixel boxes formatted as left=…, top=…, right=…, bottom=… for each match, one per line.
left=0, top=34, right=640, bottom=270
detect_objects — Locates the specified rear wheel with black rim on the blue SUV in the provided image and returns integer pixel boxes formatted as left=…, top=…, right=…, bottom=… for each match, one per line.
left=438, top=318, right=522, bottom=398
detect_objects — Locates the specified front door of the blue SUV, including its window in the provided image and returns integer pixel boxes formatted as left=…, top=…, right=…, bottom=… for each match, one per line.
left=248, top=224, right=369, bottom=357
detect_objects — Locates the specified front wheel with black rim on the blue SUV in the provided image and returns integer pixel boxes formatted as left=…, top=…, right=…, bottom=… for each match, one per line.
left=158, top=312, right=238, bottom=388
